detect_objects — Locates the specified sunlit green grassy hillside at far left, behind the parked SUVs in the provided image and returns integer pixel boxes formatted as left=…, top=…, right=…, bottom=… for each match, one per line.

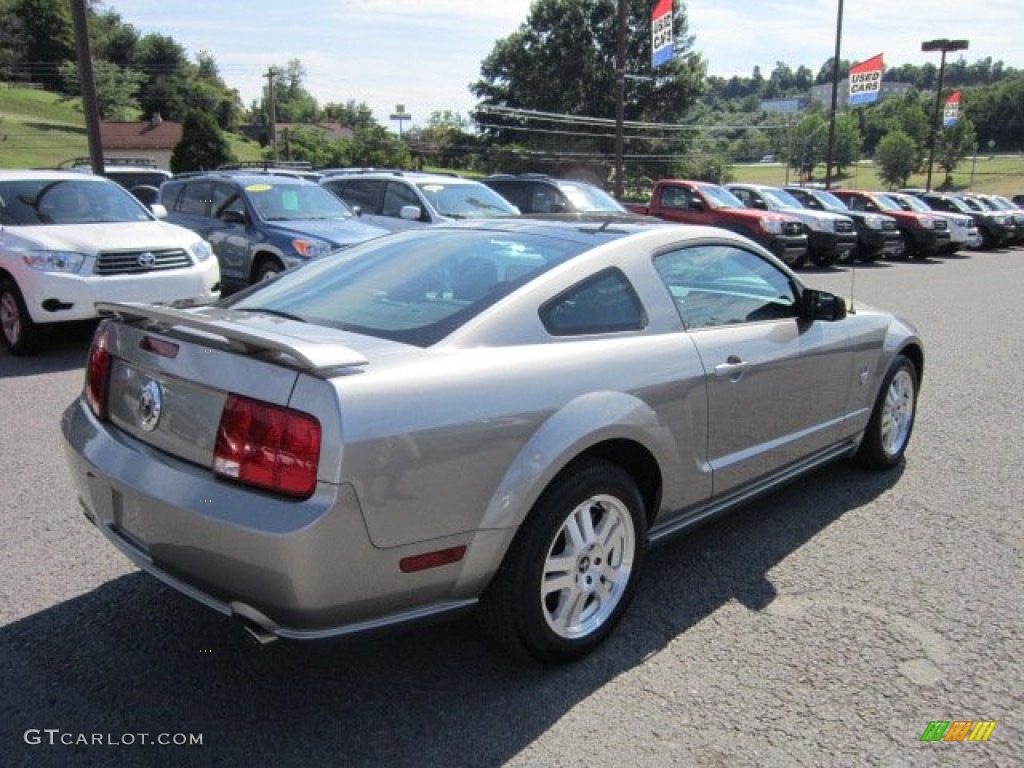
left=0, top=83, right=261, bottom=168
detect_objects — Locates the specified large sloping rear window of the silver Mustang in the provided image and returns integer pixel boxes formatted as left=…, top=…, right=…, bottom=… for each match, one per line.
left=224, top=229, right=588, bottom=346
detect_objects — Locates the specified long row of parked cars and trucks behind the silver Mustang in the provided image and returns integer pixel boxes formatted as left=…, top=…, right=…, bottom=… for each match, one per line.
left=6, top=159, right=1024, bottom=353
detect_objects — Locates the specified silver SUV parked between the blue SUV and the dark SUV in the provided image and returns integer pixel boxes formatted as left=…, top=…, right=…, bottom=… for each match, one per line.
left=321, top=169, right=519, bottom=229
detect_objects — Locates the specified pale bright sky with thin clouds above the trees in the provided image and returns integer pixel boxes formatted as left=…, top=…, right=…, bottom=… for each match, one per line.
left=103, top=0, right=1024, bottom=128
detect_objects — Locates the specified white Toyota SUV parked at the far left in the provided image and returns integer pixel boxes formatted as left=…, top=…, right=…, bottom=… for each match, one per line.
left=0, top=171, right=220, bottom=354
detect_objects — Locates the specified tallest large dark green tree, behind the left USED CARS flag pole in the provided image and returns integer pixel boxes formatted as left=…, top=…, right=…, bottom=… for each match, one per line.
left=470, top=0, right=705, bottom=182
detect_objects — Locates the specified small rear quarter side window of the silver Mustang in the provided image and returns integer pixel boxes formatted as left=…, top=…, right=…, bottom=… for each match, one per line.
left=541, top=269, right=647, bottom=336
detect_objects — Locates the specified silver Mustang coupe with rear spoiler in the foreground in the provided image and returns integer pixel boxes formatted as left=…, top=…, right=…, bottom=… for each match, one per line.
left=62, top=220, right=924, bottom=662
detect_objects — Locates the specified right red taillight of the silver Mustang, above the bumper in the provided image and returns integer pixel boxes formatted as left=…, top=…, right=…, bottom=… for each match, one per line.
left=213, top=394, right=321, bottom=498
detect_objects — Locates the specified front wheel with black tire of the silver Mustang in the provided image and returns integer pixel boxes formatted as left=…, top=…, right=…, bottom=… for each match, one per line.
left=856, top=355, right=920, bottom=469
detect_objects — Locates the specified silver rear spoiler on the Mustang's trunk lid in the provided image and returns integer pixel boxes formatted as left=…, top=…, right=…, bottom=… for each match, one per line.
left=96, top=301, right=369, bottom=372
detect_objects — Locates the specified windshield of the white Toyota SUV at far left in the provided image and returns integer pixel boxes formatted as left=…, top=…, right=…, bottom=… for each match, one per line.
left=0, top=178, right=152, bottom=226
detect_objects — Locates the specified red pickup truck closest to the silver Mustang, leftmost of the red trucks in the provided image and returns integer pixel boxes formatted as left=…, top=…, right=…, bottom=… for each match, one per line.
left=626, top=179, right=807, bottom=266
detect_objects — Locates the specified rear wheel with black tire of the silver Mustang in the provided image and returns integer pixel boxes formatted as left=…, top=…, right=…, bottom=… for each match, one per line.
left=478, top=460, right=647, bottom=664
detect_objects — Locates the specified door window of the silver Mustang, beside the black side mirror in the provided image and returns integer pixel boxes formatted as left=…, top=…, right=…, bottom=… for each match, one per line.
left=654, top=245, right=797, bottom=331
